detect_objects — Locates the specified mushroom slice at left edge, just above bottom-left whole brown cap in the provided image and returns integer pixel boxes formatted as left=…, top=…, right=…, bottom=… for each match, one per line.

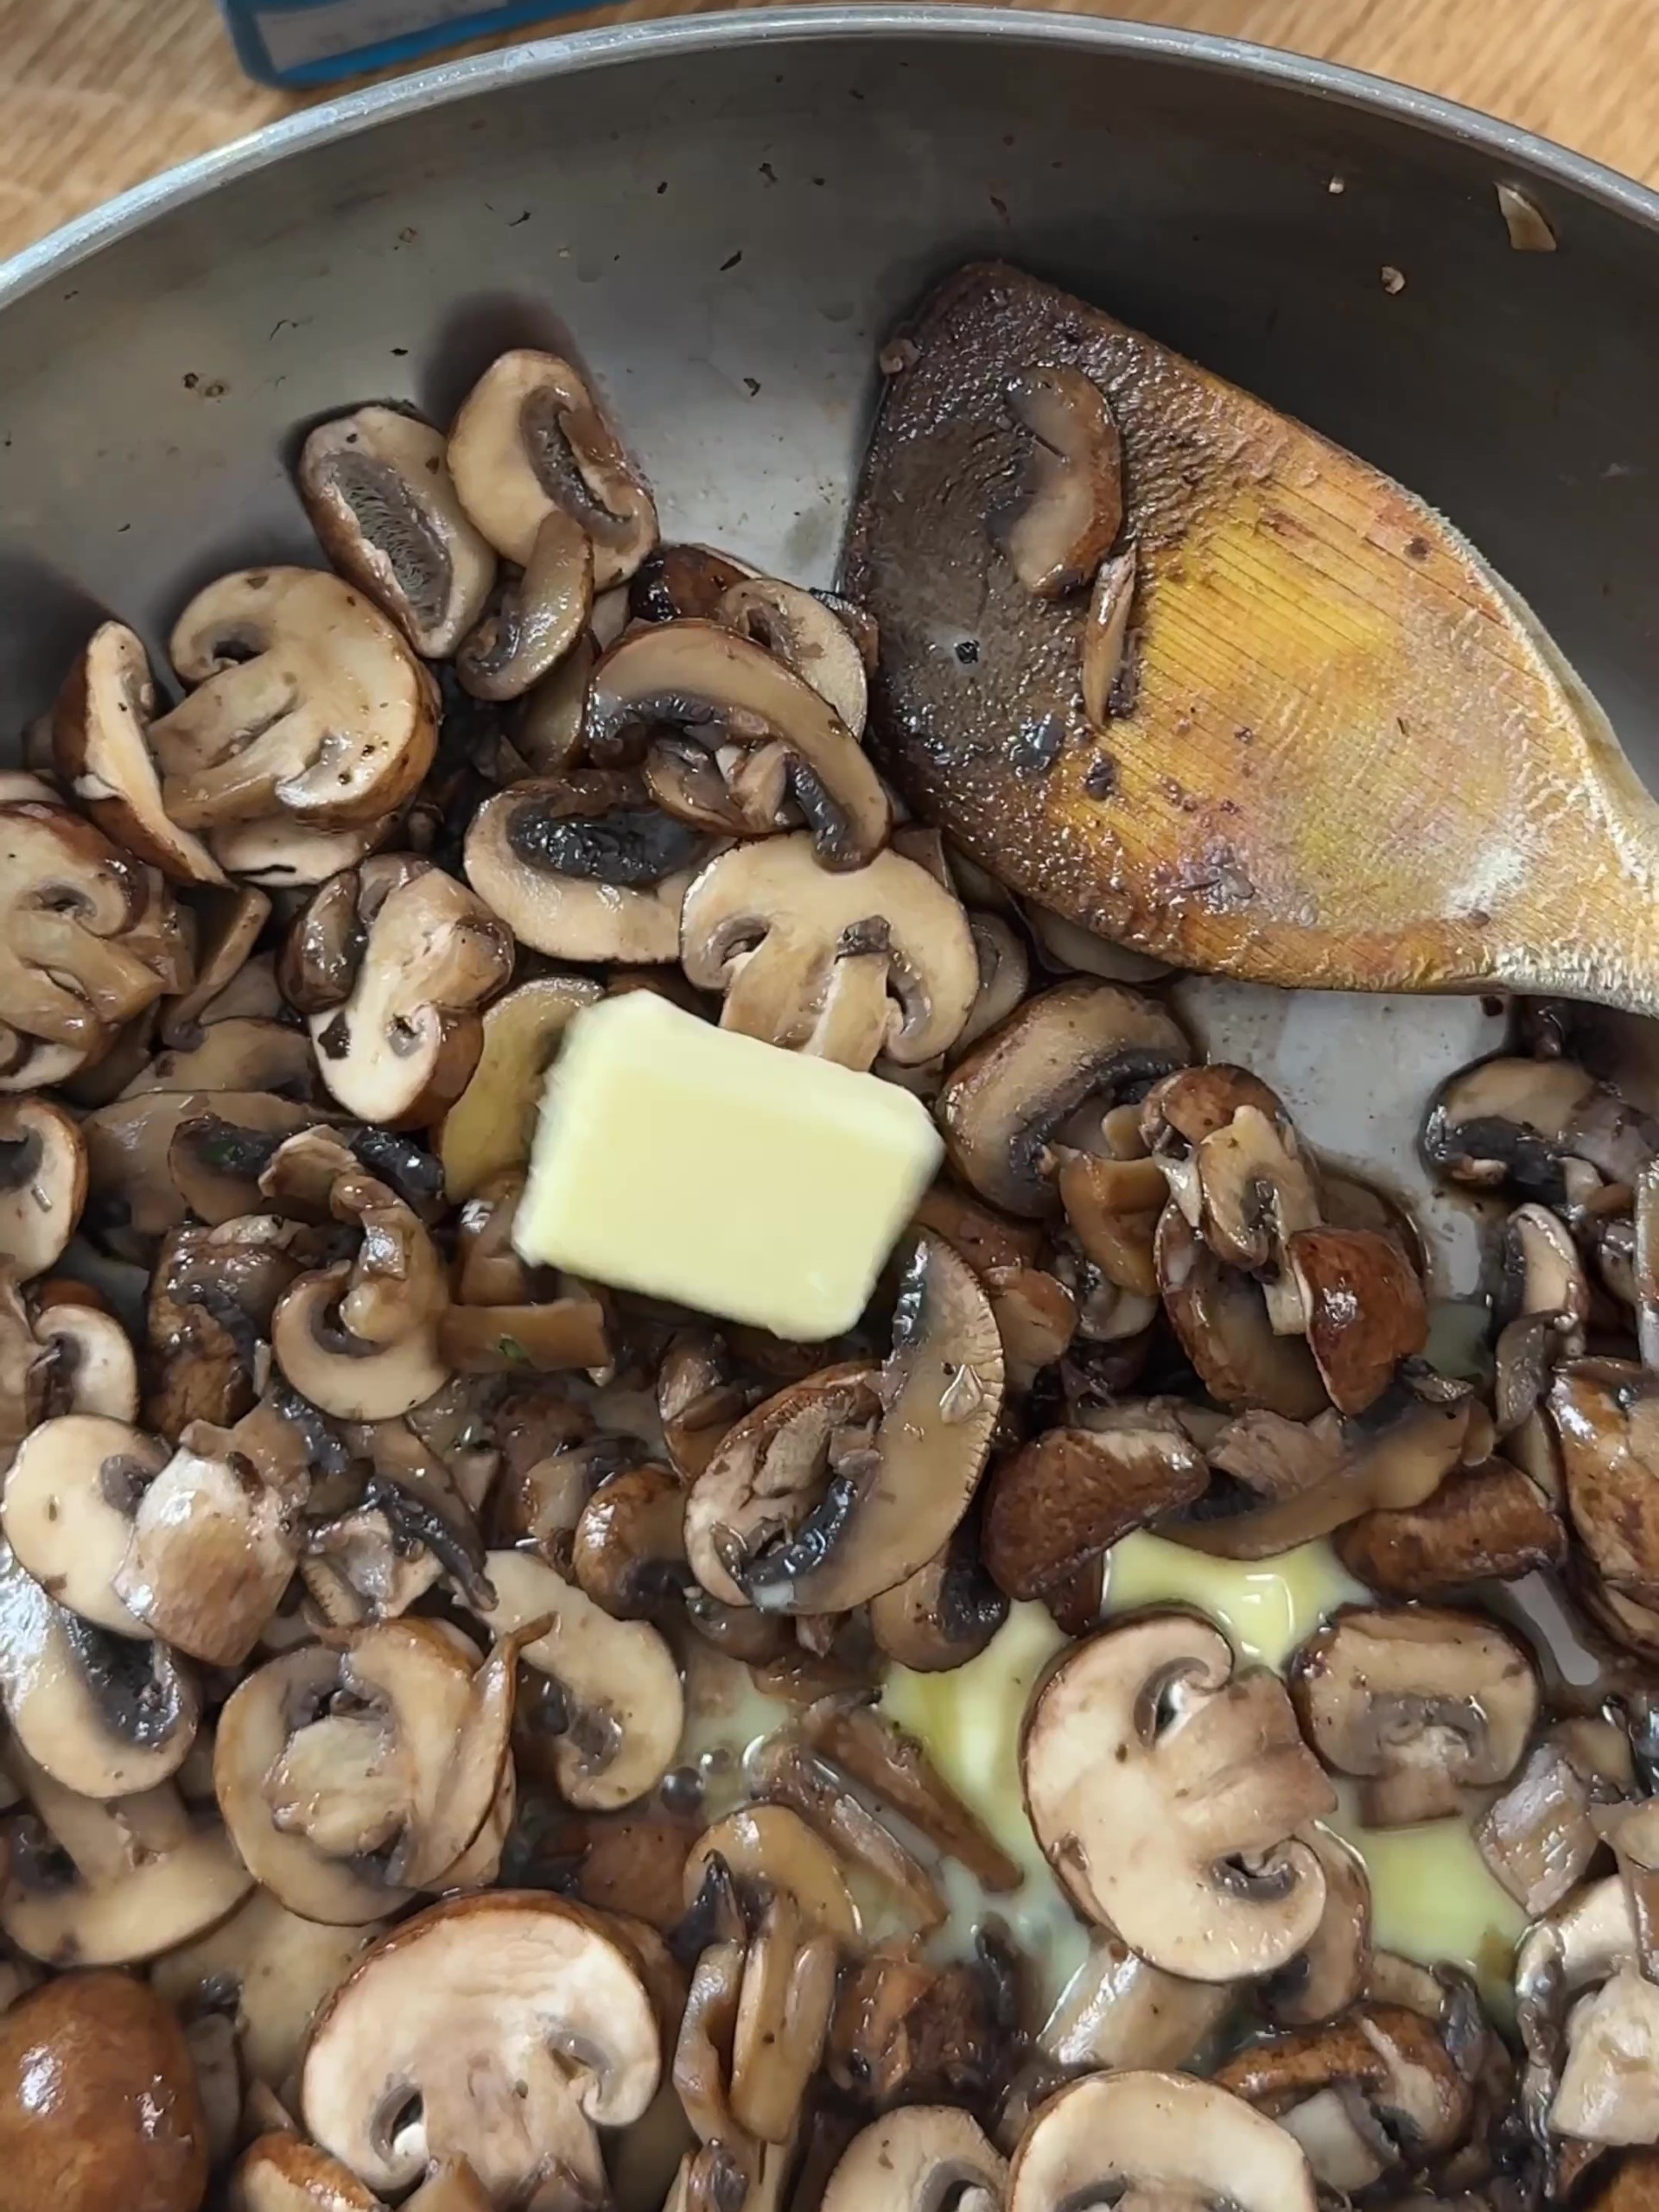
left=0, top=1745, right=254, bottom=1967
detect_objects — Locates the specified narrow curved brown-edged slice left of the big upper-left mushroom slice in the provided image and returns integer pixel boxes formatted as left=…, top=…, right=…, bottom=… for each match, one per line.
left=51, top=621, right=226, bottom=882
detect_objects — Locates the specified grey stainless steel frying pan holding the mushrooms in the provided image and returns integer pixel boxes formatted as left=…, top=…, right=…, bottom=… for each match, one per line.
left=0, top=7, right=1659, bottom=1289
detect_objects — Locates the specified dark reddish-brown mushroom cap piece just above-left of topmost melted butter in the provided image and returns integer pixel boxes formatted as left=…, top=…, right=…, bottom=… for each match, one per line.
left=982, top=1414, right=1210, bottom=1597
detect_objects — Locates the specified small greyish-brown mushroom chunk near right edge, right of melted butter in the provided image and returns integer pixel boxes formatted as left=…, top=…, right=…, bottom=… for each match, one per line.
left=1476, top=1717, right=1635, bottom=1918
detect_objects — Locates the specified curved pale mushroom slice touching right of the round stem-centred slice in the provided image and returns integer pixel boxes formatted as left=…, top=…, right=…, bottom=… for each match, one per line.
left=480, top=1551, right=686, bottom=1812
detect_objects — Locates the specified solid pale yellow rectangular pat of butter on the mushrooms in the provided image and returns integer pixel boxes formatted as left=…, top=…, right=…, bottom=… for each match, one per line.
left=513, top=991, right=944, bottom=1343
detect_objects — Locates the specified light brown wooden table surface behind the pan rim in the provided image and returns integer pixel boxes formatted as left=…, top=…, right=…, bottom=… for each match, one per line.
left=0, top=0, right=1659, bottom=254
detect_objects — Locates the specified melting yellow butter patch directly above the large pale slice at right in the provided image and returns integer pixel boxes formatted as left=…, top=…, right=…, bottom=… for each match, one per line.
left=1106, top=1531, right=1370, bottom=1668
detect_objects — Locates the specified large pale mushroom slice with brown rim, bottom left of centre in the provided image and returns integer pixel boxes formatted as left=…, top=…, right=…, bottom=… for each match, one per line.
left=301, top=1889, right=661, bottom=2203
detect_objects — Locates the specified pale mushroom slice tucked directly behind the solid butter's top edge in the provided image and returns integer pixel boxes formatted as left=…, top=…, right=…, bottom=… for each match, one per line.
left=681, top=830, right=980, bottom=1068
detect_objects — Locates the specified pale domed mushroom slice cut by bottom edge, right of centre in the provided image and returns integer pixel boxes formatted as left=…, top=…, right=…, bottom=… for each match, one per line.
left=1008, top=2073, right=1316, bottom=2212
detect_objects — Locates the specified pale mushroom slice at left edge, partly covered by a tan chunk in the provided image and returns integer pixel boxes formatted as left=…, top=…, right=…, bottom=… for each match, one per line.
left=0, top=1414, right=168, bottom=1639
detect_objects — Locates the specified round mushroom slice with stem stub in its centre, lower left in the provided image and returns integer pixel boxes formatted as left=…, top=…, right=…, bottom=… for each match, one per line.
left=214, top=1619, right=518, bottom=1927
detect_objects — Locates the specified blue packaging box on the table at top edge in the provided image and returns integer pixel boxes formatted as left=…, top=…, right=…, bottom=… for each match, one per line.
left=221, top=0, right=586, bottom=86
